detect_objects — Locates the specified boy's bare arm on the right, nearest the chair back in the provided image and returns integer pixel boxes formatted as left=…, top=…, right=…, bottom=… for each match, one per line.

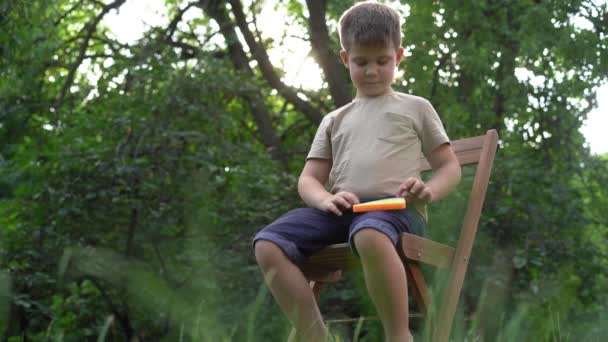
left=397, top=144, right=461, bottom=203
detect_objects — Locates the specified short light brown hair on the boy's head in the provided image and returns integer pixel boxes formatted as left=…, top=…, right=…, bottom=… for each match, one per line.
left=339, top=1, right=401, bottom=51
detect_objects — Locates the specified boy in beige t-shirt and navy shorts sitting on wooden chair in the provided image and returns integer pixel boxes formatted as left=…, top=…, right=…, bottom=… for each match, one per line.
left=254, top=1, right=460, bottom=341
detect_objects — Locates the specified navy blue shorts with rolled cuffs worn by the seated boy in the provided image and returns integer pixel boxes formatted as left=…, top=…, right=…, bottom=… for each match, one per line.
left=253, top=208, right=426, bottom=263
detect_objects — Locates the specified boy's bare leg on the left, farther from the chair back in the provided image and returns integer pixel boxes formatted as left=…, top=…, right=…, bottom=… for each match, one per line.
left=255, top=240, right=327, bottom=342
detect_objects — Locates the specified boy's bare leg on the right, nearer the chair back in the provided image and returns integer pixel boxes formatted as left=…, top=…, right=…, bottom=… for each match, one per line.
left=354, top=228, right=411, bottom=342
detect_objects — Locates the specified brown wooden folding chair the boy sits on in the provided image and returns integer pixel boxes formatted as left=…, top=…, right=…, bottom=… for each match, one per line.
left=292, top=130, right=498, bottom=342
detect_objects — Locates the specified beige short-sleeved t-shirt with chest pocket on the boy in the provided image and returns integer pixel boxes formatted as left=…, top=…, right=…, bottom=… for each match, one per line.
left=306, top=92, right=450, bottom=218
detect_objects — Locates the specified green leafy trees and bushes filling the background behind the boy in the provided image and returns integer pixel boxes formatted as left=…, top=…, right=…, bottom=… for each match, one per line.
left=0, top=0, right=608, bottom=341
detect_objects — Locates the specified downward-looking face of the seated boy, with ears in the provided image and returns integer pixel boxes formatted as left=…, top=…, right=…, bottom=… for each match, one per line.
left=340, top=45, right=403, bottom=97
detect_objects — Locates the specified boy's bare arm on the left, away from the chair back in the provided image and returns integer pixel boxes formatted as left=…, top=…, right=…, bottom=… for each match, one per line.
left=298, top=159, right=359, bottom=215
